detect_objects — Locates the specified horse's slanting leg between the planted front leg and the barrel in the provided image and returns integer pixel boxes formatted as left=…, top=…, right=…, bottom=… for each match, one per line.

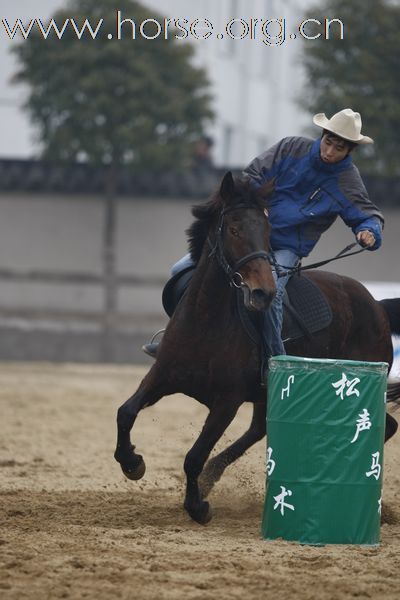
left=199, top=402, right=266, bottom=498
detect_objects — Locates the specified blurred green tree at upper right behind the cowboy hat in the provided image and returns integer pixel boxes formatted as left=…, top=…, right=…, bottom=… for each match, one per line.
left=300, top=0, right=400, bottom=175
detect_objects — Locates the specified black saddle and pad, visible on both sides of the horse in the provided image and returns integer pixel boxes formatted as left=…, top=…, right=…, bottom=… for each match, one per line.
left=162, top=267, right=332, bottom=345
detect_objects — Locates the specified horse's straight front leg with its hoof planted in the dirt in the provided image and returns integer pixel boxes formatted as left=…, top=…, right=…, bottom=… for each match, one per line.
left=184, top=396, right=242, bottom=524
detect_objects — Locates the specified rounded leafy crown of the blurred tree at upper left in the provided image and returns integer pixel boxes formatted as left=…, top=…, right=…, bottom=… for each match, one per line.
left=15, top=0, right=212, bottom=168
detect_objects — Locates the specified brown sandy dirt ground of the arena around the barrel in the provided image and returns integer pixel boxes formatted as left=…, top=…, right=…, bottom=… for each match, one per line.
left=0, top=363, right=400, bottom=600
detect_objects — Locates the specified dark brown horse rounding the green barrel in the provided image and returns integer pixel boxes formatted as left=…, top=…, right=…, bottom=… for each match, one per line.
left=114, top=172, right=400, bottom=524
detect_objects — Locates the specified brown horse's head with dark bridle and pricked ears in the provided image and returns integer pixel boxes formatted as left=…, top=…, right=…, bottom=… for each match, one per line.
left=209, top=172, right=276, bottom=310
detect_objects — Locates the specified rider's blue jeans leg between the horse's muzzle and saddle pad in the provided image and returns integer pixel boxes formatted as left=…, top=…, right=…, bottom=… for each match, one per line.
left=263, top=250, right=300, bottom=356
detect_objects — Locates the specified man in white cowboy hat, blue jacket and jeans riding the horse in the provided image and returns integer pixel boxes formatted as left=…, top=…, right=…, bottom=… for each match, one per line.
left=143, top=108, right=384, bottom=356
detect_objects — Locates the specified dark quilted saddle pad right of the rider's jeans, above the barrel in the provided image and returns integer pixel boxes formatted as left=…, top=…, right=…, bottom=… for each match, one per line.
left=282, top=275, right=332, bottom=341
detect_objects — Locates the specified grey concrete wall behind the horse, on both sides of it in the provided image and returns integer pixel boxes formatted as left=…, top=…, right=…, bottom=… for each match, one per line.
left=0, top=193, right=400, bottom=361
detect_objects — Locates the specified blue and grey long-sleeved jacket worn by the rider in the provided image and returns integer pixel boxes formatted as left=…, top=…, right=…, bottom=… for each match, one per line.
left=244, top=137, right=384, bottom=256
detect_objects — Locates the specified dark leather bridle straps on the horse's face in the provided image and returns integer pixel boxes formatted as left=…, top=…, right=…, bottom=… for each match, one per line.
left=207, top=204, right=275, bottom=288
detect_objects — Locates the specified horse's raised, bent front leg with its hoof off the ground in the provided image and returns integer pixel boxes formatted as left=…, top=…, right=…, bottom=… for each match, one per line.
left=114, top=375, right=165, bottom=479
